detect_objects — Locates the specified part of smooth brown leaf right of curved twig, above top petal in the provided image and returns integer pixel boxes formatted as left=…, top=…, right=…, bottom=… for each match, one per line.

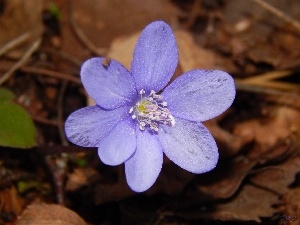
left=71, top=0, right=177, bottom=46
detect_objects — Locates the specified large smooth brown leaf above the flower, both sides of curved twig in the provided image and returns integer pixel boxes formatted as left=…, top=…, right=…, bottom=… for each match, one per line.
left=59, top=0, right=177, bottom=64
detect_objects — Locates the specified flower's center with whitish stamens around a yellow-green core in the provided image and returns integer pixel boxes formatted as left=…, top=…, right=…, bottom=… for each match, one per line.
left=129, top=89, right=175, bottom=131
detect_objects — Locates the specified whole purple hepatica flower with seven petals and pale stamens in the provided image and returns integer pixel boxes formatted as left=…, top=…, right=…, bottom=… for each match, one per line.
left=65, top=21, right=235, bottom=192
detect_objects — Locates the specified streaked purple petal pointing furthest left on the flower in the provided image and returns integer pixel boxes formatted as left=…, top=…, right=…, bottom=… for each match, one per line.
left=65, top=106, right=129, bottom=147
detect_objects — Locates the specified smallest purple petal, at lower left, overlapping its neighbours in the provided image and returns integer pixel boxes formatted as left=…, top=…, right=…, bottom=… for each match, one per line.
left=98, top=118, right=136, bottom=166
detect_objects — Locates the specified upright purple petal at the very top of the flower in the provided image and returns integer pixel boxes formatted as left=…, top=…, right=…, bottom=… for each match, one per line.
left=131, top=21, right=178, bottom=92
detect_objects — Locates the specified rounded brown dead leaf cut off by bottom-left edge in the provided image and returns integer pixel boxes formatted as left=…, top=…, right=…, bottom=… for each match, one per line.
left=16, top=203, right=87, bottom=225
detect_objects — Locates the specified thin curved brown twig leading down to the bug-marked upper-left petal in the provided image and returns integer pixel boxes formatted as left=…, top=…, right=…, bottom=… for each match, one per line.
left=69, top=1, right=107, bottom=56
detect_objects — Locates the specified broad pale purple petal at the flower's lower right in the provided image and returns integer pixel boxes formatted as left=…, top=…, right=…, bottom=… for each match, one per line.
left=158, top=118, right=219, bottom=173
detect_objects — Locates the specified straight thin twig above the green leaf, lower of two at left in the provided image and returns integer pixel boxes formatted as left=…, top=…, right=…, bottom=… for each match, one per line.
left=0, top=39, right=42, bottom=85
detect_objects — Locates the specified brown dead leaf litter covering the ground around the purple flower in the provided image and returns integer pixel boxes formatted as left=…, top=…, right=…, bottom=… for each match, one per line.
left=0, top=0, right=300, bottom=225
